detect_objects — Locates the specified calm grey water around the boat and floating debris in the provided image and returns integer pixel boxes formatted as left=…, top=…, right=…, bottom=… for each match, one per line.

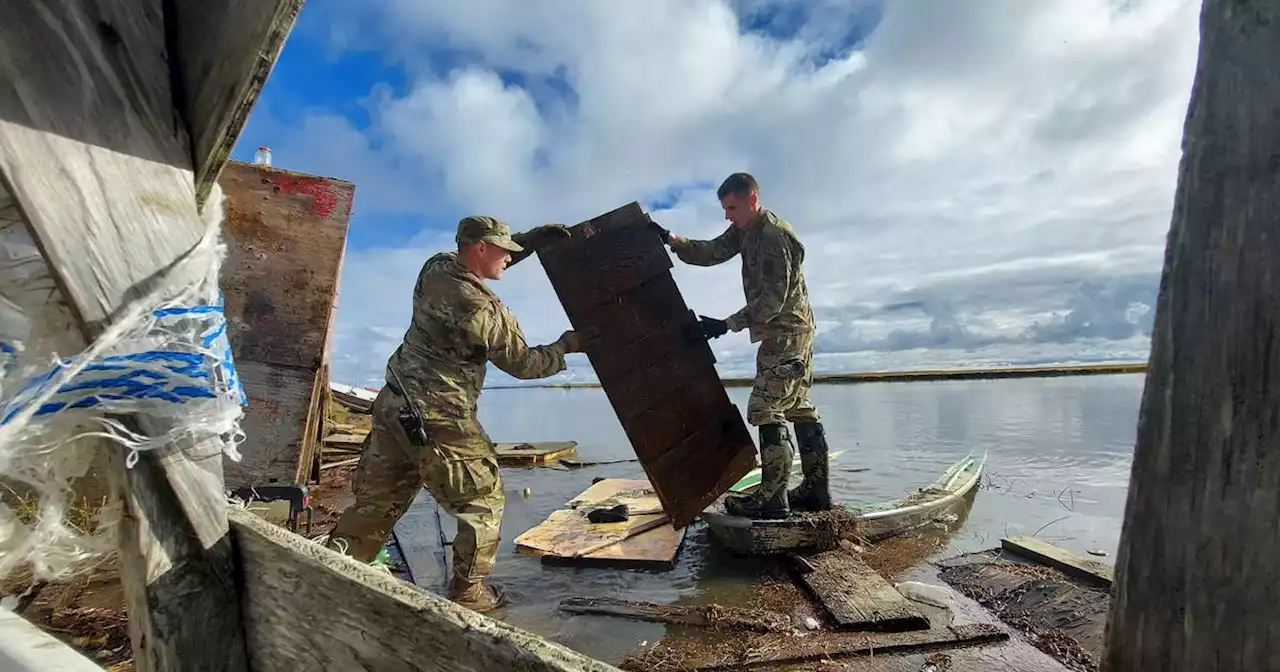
left=435, top=374, right=1143, bottom=662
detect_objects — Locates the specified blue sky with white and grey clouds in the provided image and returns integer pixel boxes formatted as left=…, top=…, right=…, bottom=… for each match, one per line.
left=227, top=0, right=1199, bottom=385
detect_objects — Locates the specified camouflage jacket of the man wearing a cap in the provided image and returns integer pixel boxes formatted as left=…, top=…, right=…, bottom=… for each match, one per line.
left=387, top=252, right=564, bottom=430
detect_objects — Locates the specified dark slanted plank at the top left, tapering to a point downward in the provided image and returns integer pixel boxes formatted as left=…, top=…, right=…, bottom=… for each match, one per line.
left=165, top=0, right=303, bottom=202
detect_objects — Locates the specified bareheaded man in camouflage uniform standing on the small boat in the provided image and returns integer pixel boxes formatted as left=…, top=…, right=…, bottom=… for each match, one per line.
left=653, top=173, right=831, bottom=518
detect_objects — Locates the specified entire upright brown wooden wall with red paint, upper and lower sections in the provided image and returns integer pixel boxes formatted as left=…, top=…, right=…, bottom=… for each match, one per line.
left=219, top=161, right=355, bottom=488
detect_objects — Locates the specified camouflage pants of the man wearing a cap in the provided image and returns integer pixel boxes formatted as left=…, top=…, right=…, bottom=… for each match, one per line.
left=329, top=387, right=506, bottom=582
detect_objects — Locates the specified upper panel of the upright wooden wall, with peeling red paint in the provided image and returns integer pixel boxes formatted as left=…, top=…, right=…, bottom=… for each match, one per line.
left=218, top=161, right=355, bottom=370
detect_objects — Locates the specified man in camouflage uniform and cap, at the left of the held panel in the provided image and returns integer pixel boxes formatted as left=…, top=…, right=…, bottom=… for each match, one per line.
left=328, top=216, right=581, bottom=612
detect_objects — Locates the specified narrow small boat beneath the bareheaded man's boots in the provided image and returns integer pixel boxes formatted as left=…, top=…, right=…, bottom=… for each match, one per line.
left=701, top=453, right=987, bottom=556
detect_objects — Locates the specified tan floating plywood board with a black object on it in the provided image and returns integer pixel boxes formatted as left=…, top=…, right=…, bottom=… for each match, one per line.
left=516, top=479, right=685, bottom=570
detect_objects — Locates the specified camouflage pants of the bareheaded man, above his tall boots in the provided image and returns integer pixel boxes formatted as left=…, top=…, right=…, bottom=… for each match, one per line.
left=746, top=332, right=819, bottom=425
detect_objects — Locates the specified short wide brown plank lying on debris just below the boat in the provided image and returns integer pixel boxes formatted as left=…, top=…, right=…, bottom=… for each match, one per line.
left=800, top=550, right=929, bottom=631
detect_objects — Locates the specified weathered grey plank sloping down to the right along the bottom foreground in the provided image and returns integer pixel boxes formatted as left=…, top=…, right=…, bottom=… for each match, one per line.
left=228, top=511, right=617, bottom=672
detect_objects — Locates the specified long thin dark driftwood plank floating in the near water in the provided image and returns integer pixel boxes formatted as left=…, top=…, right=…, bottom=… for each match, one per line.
left=559, top=598, right=794, bottom=632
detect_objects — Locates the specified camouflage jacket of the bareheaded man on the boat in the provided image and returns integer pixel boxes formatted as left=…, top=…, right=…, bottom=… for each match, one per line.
left=671, top=207, right=814, bottom=343
